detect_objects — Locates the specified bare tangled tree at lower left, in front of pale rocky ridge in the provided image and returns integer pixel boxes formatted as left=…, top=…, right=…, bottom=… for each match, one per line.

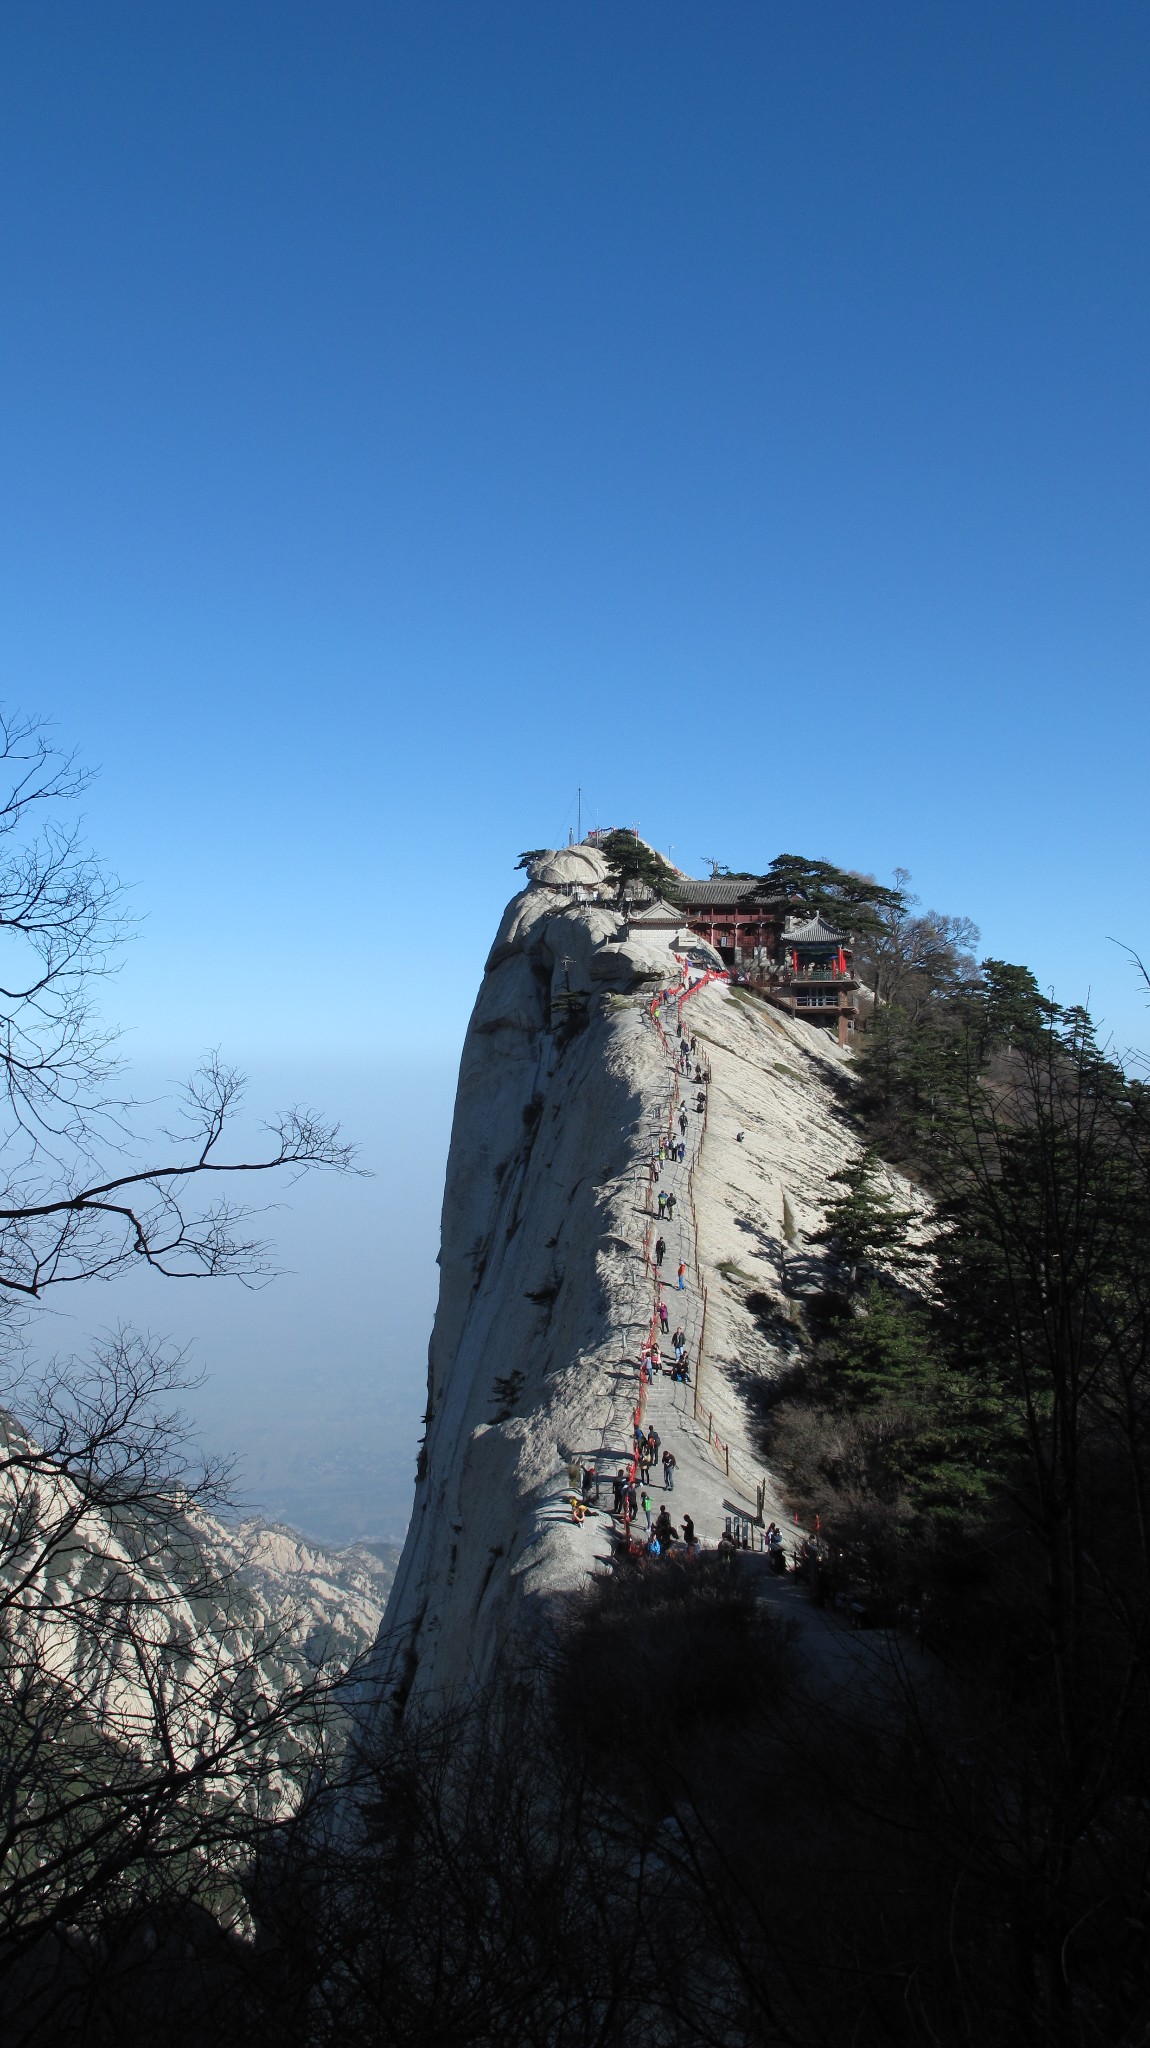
left=0, top=1337, right=358, bottom=2028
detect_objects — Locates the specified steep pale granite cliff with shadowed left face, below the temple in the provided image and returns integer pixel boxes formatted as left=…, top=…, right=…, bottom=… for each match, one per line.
left=362, top=846, right=908, bottom=1714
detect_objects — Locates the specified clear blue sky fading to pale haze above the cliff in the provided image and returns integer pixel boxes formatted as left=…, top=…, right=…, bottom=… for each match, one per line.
left=0, top=0, right=1150, bottom=1534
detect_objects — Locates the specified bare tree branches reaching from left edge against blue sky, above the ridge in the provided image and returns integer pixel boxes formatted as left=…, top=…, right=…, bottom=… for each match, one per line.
left=0, top=717, right=352, bottom=1309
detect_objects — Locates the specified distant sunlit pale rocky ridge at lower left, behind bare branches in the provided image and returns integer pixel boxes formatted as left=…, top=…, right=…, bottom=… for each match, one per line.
left=0, top=1415, right=393, bottom=1800
